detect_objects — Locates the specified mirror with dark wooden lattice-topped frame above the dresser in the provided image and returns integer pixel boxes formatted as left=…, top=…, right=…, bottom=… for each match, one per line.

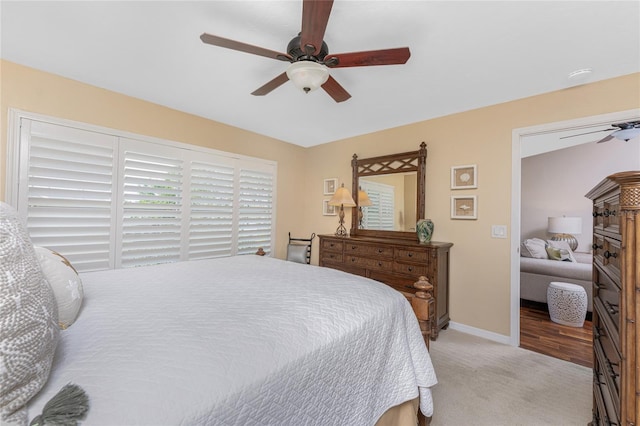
left=351, top=142, right=427, bottom=240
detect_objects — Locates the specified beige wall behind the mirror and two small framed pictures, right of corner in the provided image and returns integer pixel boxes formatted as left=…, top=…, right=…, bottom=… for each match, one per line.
left=305, top=74, right=640, bottom=336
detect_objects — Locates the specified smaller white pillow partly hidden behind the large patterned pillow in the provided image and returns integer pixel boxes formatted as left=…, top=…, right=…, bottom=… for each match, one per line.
left=34, top=246, right=84, bottom=330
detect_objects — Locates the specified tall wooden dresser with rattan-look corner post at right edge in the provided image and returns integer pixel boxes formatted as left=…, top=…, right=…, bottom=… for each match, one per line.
left=586, top=171, right=640, bottom=425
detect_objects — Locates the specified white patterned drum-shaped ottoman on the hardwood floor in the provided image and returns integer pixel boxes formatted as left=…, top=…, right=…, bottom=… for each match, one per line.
left=547, top=281, right=587, bottom=327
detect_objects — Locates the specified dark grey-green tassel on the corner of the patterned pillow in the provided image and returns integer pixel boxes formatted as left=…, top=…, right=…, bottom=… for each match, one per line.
left=30, top=383, right=89, bottom=426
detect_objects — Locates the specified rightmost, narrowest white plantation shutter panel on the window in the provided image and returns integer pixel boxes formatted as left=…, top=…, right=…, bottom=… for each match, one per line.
left=238, top=167, right=275, bottom=254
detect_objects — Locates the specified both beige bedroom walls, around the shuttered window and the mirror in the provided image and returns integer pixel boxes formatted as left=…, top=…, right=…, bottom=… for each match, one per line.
left=0, top=61, right=640, bottom=335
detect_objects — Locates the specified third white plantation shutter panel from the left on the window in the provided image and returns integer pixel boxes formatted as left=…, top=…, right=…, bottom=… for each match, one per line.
left=188, top=161, right=234, bottom=259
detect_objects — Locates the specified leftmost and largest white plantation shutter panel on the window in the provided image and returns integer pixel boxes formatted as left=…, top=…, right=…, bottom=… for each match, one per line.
left=18, top=118, right=117, bottom=271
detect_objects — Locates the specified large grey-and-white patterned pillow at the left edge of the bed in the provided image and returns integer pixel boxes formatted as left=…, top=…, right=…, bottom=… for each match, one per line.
left=0, top=202, right=60, bottom=425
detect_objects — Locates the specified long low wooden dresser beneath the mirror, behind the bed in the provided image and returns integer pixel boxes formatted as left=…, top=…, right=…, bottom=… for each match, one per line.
left=319, top=235, right=453, bottom=340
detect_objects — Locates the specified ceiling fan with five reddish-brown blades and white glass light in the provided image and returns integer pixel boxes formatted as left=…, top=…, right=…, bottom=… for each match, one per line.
left=200, top=0, right=411, bottom=102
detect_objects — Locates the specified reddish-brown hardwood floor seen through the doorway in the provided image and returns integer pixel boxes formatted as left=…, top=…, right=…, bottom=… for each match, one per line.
left=520, top=303, right=593, bottom=368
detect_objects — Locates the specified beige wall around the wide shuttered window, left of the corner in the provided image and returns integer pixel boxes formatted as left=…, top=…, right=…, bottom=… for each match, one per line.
left=0, top=61, right=306, bottom=258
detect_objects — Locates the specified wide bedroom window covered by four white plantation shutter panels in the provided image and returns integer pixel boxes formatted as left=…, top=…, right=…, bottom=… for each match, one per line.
left=8, top=115, right=276, bottom=271
